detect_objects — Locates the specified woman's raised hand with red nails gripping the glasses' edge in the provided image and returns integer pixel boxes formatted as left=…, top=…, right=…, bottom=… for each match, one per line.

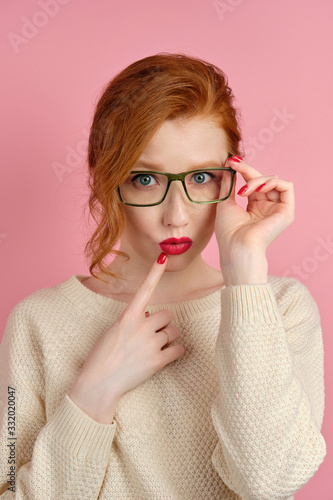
left=215, top=158, right=295, bottom=265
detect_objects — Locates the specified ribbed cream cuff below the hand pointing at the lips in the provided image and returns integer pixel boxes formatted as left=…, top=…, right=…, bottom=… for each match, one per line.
left=46, top=394, right=117, bottom=461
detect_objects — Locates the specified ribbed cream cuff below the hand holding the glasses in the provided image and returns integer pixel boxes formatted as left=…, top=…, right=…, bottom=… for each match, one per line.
left=221, top=283, right=282, bottom=324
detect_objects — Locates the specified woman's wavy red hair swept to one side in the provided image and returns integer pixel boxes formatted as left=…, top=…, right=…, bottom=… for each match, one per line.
left=85, top=52, right=243, bottom=283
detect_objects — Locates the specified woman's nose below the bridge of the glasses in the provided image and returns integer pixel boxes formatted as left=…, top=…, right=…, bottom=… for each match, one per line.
left=161, top=181, right=189, bottom=226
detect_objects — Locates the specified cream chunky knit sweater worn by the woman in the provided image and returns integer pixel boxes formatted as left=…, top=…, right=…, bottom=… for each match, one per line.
left=0, top=275, right=326, bottom=500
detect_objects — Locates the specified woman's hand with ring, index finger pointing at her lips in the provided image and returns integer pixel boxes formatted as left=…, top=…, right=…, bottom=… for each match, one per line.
left=68, top=254, right=184, bottom=423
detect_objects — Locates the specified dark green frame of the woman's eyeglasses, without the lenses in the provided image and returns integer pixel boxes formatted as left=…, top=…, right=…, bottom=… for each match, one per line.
left=117, top=155, right=236, bottom=207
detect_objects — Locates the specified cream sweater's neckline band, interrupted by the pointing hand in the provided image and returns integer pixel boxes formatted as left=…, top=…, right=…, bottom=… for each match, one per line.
left=56, top=274, right=225, bottom=320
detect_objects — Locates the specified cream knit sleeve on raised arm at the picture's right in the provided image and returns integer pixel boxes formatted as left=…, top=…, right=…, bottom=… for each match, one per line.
left=211, top=278, right=326, bottom=500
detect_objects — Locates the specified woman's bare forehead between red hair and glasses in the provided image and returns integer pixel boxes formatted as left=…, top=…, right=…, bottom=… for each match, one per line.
left=139, top=117, right=228, bottom=169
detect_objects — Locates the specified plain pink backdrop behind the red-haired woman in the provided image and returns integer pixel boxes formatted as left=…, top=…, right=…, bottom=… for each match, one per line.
left=0, top=0, right=333, bottom=500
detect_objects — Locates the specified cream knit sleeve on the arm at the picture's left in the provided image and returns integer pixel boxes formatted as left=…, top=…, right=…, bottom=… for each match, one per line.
left=0, top=304, right=116, bottom=500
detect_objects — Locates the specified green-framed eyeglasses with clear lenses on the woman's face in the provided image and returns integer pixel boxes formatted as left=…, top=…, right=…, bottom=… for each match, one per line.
left=118, top=155, right=236, bottom=207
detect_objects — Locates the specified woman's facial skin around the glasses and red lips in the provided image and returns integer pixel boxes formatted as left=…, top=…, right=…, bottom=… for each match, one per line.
left=120, top=117, right=228, bottom=271
